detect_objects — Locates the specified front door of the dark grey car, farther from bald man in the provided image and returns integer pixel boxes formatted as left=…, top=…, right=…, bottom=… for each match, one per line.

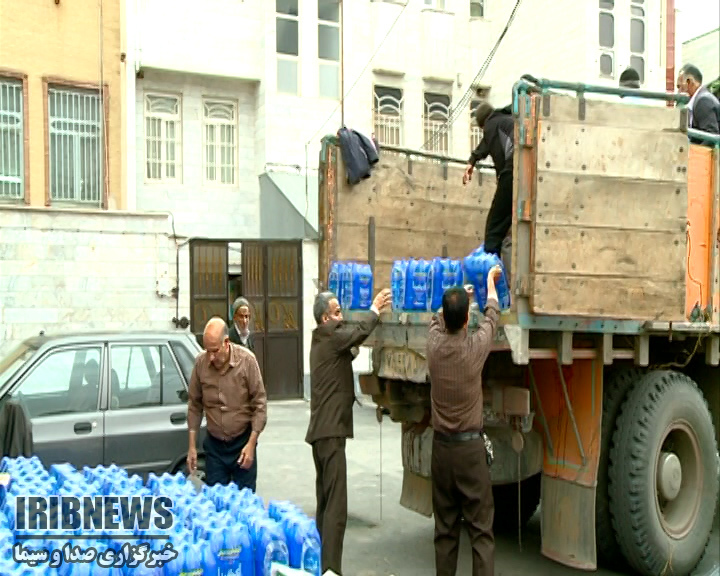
left=11, top=344, right=104, bottom=468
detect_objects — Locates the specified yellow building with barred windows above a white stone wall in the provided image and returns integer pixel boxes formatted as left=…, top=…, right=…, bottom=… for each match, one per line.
left=0, top=0, right=175, bottom=355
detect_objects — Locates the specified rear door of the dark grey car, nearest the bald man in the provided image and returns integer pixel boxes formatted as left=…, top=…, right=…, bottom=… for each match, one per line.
left=105, top=341, right=188, bottom=475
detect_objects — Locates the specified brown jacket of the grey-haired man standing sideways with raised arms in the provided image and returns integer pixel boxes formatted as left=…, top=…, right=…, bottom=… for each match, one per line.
left=305, top=312, right=379, bottom=444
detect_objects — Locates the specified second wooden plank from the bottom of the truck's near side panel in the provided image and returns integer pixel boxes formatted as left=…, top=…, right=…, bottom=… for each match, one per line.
left=534, top=226, right=687, bottom=286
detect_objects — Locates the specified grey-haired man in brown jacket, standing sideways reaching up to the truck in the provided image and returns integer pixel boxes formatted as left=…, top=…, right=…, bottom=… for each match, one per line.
left=305, top=290, right=391, bottom=574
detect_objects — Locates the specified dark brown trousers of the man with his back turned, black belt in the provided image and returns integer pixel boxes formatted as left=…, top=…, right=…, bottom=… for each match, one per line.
left=430, top=437, right=495, bottom=576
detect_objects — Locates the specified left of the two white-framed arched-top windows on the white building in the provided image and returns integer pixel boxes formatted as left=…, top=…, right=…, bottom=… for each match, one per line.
left=145, top=94, right=182, bottom=180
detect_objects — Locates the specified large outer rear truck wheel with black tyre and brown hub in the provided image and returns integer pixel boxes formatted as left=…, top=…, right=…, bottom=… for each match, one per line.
left=609, top=370, right=719, bottom=576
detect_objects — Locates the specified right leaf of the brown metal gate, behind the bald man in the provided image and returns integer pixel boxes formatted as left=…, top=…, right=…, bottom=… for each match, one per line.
left=242, top=241, right=303, bottom=399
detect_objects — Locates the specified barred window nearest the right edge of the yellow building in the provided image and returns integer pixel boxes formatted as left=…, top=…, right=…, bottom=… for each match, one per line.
left=48, top=87, right=105, bottom=205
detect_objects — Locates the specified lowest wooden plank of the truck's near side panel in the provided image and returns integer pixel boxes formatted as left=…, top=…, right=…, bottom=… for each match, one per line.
left=532, top=274, right=685, bottom=322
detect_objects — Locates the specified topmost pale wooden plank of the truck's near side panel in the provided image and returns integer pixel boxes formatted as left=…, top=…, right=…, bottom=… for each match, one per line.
left=540, top=94, right=681, bottom=131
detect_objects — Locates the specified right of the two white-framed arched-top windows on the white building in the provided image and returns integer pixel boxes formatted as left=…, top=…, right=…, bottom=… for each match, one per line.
left=203, top=100, right=237, bottom=184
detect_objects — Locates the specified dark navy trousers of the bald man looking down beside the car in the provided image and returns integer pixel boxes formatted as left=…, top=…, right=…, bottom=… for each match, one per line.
left=203, top=426, right=257, bottom=492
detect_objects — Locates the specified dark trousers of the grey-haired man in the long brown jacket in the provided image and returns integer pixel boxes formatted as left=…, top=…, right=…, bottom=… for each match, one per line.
left=312, top=438, right=347, bottom=574
